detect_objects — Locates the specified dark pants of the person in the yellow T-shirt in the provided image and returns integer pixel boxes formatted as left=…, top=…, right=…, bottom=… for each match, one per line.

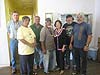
left=20, top=54, right=34, bottom=75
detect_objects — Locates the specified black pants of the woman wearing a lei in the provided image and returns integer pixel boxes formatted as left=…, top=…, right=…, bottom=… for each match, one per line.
left=56, top=50, right=64, bottom=70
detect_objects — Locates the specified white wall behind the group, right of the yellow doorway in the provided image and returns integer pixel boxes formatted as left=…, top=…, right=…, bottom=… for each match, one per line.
left=38, top=0, right=95, bottom=46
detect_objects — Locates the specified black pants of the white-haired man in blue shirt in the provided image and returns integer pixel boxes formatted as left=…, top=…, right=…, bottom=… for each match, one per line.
left=74, top=47, right=87, bottom=74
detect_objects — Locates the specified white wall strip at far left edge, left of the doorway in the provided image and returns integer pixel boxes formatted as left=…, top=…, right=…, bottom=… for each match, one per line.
left=0, top=0, right=10, bottom=67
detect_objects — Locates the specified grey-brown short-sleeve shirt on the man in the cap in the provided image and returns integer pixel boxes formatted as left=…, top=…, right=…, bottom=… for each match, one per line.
left=40, top=27, right=55, bottom=50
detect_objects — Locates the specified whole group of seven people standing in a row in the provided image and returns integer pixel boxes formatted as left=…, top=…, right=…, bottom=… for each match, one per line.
left=7, top=11, right=92, bottom=75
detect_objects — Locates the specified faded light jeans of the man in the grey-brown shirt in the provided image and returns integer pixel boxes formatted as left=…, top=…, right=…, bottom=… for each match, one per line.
left=43, top=50, right=56, bottom=73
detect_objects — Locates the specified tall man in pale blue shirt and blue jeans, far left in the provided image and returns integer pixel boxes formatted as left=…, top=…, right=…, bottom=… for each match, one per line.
left=7, top=11, right=22, bottom=73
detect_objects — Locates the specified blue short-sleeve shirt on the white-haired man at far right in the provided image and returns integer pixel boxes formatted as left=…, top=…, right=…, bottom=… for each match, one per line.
left=73, top=22, right=92, bottom=48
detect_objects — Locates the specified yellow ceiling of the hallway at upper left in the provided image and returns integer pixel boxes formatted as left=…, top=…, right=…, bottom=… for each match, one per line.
left=8, top=0, right=37, bottom=15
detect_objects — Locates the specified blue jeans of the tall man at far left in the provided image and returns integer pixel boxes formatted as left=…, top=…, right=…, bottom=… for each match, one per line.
left=10, top=39, right=18, bottom=69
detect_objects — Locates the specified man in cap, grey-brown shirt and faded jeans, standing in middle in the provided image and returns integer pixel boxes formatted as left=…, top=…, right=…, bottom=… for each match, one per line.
left=40, top=18, right=56, bottom=74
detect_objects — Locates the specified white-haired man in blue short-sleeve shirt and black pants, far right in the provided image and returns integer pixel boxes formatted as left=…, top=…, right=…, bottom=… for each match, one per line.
left=69, top=13, right=92, bottom=75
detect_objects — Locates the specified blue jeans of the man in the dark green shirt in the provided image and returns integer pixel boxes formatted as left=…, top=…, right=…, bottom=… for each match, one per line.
left=34, top=47, right=43, bottom=66
